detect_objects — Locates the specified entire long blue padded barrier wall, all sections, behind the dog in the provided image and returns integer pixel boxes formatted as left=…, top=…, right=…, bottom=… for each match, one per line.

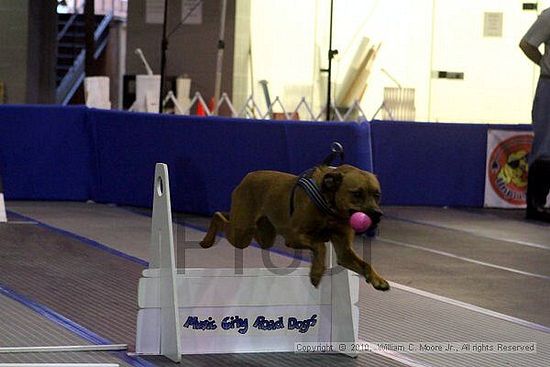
left=0, top=106, right=531, bottom=214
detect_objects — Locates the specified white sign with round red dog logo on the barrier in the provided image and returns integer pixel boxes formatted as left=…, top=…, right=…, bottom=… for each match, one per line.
left=484, top=130, right=533, bottom=208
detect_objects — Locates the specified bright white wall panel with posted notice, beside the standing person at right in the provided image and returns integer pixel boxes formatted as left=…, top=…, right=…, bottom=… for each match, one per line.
left=430, top=0, right=536, bottom=123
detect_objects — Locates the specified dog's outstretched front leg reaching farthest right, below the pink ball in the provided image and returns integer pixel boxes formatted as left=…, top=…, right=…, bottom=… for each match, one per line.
left=331, top=232, right=390, bottom=291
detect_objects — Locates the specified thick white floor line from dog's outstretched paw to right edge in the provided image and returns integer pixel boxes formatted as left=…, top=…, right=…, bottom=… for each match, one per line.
left=390, top=282, right=550, bottom=334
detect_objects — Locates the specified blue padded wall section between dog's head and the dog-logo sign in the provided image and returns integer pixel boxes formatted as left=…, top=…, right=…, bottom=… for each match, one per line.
left=371, top=121, right=487, bottom=207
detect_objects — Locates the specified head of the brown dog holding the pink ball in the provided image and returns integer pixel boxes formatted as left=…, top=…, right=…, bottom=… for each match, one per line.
left=321, top=165, right=383, bottom=226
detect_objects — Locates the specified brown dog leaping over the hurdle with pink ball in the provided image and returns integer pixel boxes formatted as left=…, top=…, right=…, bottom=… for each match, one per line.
left=201, top=165, right=390, bottom=291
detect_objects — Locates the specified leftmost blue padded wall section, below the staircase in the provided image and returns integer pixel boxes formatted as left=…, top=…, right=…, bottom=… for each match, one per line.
left=0, top=106, right=92, bottom=200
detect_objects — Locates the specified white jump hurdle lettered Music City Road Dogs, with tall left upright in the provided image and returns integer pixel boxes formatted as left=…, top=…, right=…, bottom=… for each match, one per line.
left=136, top=163, right=359, bottom=362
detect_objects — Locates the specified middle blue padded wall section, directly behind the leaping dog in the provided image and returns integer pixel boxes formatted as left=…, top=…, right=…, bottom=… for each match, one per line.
left=89, top=111, right=371, bottom=214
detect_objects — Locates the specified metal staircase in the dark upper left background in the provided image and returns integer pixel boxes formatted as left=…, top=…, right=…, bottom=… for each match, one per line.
left=56, top=13, right=113, bottom=105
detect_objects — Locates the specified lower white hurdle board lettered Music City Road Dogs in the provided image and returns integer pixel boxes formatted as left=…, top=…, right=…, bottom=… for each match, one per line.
left=136, top=306, right=331, bottom=354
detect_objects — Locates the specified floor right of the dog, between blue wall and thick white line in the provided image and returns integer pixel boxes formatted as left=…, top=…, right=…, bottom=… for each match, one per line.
left=380, top=208, right=550, bottom=327
